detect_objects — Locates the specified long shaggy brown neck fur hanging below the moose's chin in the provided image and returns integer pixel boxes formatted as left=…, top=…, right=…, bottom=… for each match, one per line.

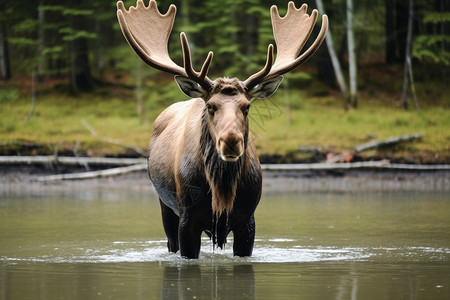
left=201, top=109, right=248, bottom=217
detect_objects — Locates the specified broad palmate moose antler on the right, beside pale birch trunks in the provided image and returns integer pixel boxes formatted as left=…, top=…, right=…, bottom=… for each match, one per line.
left=244, top=1, right=328, bottom=90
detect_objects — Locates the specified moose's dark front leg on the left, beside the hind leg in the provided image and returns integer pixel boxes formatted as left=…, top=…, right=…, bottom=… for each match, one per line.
left=178, top=212, right=202, bottom=258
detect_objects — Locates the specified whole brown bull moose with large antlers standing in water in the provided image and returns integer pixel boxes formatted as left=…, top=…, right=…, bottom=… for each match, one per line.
left=117, top=0, right=328, bottom=258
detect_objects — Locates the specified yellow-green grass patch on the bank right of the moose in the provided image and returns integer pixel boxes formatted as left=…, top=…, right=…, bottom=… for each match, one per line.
left=252, top=93, right=450, bottom=160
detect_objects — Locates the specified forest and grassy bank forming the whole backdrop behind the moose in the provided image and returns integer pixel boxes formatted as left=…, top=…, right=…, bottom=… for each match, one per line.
left=0, top=0, right=450, bottom=163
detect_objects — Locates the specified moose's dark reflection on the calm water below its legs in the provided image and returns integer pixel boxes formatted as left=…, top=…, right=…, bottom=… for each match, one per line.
left=161, top=264, right=255, bottom=299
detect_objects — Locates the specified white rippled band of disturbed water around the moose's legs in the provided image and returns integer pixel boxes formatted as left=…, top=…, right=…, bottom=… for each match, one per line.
left=0, top=238, right=450, bottom=264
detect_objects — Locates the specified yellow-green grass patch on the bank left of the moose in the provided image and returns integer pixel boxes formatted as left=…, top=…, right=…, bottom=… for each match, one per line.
left=0, top=95, right=151, bottom=155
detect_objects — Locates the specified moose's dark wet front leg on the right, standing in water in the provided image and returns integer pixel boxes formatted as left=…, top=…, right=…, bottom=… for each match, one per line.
left=233, top=215, right=255, bottom=256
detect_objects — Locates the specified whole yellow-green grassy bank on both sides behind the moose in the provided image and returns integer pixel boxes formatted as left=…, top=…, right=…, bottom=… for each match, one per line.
left=0, top=77, right=450, bottom=162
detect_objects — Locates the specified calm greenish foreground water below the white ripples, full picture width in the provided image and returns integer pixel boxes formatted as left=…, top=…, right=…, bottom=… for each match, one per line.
left=0, top=261, right=450, bottom=300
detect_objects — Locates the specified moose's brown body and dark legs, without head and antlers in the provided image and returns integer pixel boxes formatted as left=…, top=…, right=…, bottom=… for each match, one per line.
left=148, top=80, right=262, bottom=258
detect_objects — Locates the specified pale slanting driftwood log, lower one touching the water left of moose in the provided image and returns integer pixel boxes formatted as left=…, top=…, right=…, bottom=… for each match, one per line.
left=36, top=164, right=147, bottom=182
